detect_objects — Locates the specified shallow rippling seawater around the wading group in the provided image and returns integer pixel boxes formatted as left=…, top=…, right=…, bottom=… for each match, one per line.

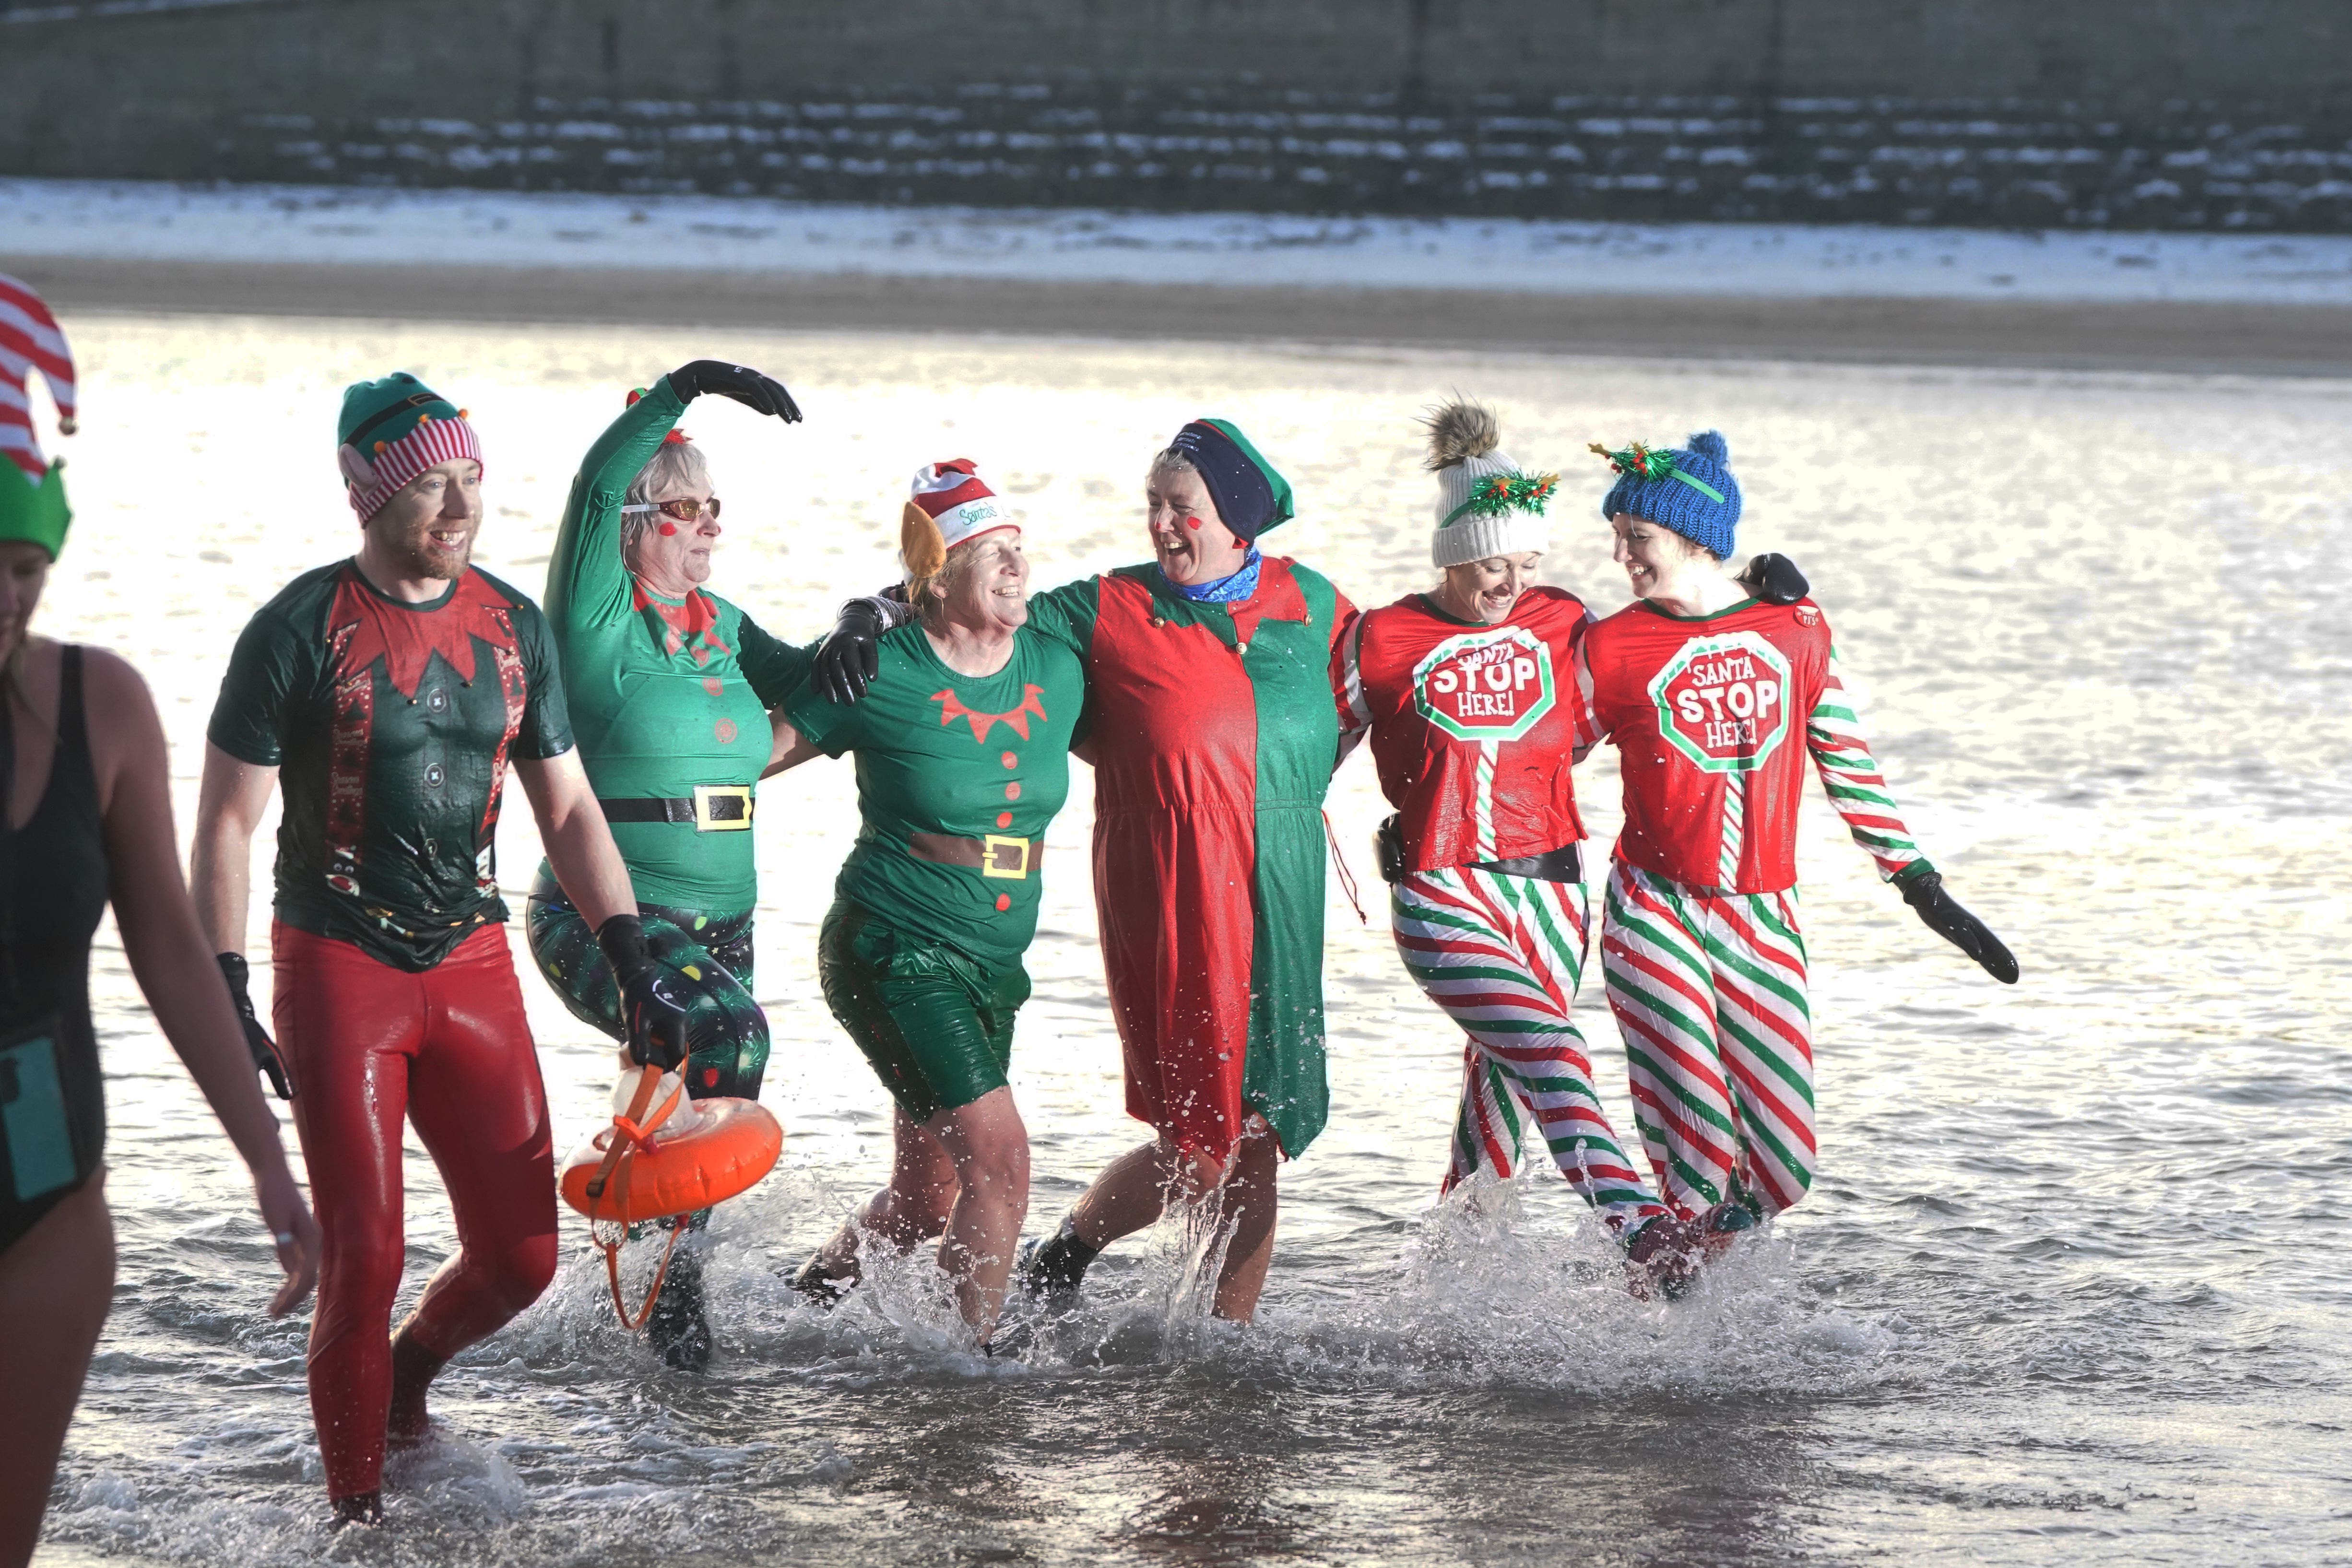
left=23, top=319, right=2352, bottom=1568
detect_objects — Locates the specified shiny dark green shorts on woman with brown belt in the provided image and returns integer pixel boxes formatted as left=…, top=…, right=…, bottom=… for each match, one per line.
left=816, top=900, right=1030, bottom=1124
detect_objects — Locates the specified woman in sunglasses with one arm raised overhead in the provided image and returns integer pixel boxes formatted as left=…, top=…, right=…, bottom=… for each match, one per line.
left=527, top=360, right=809, bottom=1368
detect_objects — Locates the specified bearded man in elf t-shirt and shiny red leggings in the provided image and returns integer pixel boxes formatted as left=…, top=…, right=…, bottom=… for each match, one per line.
left=195, top=374, right=685, bottom=1521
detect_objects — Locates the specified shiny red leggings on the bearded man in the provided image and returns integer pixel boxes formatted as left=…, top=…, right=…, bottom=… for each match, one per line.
left=271, top=924, right=555, bottom=1497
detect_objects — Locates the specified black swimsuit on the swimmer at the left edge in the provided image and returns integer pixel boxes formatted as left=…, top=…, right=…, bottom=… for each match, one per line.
left=0, top=647, right=106, bottom=1250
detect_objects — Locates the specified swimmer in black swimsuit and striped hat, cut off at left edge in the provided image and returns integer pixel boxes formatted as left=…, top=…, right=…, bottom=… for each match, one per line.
left=0, top=277, right=320, bottom=1568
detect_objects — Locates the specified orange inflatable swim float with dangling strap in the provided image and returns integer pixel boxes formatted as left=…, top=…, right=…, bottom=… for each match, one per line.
left=560, top=1067, right=783, bottom=1331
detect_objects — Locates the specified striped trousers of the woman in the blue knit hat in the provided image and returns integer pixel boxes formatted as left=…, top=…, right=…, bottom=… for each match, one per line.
left=1602, top=861, right=1813, bottom=1218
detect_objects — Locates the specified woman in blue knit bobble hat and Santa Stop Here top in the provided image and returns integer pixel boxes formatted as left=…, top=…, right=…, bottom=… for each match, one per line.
left=1578, top=430, right=2018, bottom=1288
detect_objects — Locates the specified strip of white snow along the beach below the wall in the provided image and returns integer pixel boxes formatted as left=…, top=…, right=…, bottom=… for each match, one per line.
left=0, top=178, right=2352, bottom=306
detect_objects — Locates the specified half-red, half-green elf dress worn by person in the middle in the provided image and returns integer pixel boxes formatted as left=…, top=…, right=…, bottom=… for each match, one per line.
left=1030, top=555, right=1355, bottom=1159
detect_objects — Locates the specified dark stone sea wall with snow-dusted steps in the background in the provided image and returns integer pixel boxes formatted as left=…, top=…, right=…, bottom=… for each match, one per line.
left=0, top=0, right=2352, bottom=230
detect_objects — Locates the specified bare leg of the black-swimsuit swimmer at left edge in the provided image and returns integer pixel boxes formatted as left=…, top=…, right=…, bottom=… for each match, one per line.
left=0, top=1171, right=115, bottom=1568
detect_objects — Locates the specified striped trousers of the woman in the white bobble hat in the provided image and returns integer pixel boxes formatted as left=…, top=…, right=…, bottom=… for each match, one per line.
left=1390, top=865, right=1665, bottom=1234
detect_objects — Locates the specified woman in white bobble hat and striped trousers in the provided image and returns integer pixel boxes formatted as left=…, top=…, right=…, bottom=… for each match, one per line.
left=1334, top=400, right=1684, bottom=1286
